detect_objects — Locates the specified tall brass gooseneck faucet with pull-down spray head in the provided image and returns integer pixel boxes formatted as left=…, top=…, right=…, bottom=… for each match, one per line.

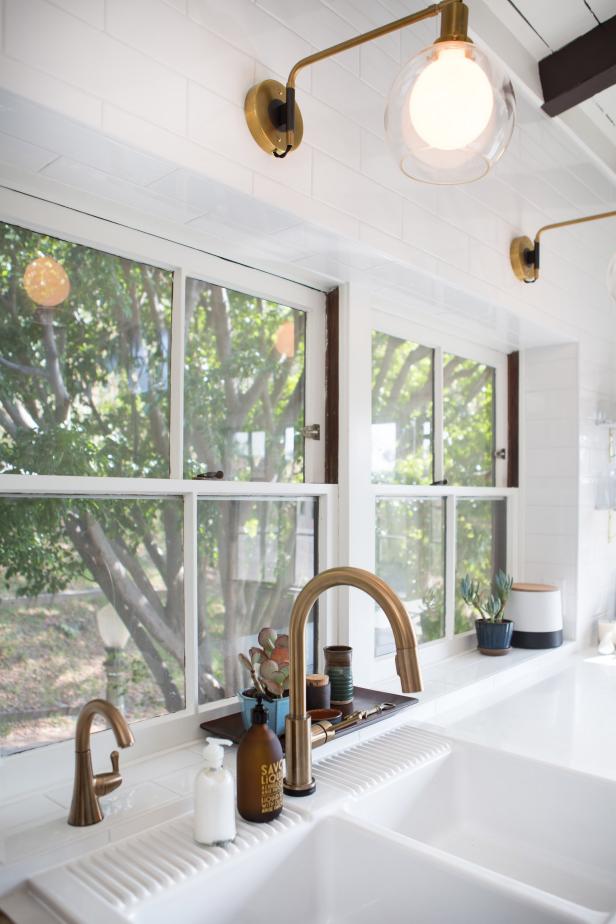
left=284, top=567, right=422, bottom=796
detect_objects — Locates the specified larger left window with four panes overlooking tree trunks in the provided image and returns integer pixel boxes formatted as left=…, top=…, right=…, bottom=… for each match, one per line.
left=0, top=194, right=335, bottom=754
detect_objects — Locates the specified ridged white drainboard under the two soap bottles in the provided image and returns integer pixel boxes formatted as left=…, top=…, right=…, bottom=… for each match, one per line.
left=35, top=807, right=304, bottom=913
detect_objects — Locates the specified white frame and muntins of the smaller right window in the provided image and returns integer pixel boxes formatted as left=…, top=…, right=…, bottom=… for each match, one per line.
left=339, top=285, right=518, bottom=688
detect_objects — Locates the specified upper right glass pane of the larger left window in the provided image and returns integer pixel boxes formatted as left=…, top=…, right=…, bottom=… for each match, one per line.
left=184, top=279, right=306, bottom=481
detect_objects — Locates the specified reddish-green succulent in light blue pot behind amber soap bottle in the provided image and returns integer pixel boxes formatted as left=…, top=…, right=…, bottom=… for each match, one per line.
left=238, top=626, right=289, bottom=735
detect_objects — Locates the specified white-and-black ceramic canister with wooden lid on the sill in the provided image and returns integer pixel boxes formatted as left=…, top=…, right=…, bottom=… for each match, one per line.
left=505, top=584, right=563, bottom=648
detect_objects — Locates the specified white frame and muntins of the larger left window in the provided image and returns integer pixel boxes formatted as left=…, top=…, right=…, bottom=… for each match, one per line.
left=0, top=189, right=338, bottom=793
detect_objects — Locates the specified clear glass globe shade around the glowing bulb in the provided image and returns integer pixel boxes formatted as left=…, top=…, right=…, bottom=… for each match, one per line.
left=385, top=41, right=515, bottom=185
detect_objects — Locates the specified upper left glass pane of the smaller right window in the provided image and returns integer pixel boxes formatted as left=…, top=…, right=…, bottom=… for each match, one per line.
left=372, top=331, right=434, bottom=484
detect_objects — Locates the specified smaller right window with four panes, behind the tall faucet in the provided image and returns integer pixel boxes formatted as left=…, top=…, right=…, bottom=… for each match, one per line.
left=371, top=313, right=513, bottom=658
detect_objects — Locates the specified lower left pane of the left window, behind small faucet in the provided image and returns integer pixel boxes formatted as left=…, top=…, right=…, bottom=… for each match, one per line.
left=0, top=496, right=184, bottom=753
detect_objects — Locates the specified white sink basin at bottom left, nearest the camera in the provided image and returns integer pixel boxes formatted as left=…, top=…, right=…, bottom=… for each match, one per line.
left=25, top=816, right=594, bottom=924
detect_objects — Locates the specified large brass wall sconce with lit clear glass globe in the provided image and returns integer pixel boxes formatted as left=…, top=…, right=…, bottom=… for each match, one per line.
left=244, top=0, right=515, bottom=184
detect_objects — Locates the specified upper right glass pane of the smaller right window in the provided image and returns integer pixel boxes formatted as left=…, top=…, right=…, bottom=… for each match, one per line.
left=443, top=353, right=495, bottom=486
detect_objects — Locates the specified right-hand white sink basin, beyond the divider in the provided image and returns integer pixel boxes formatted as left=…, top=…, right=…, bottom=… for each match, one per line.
left=350, top=742, right=616, bottom=920
